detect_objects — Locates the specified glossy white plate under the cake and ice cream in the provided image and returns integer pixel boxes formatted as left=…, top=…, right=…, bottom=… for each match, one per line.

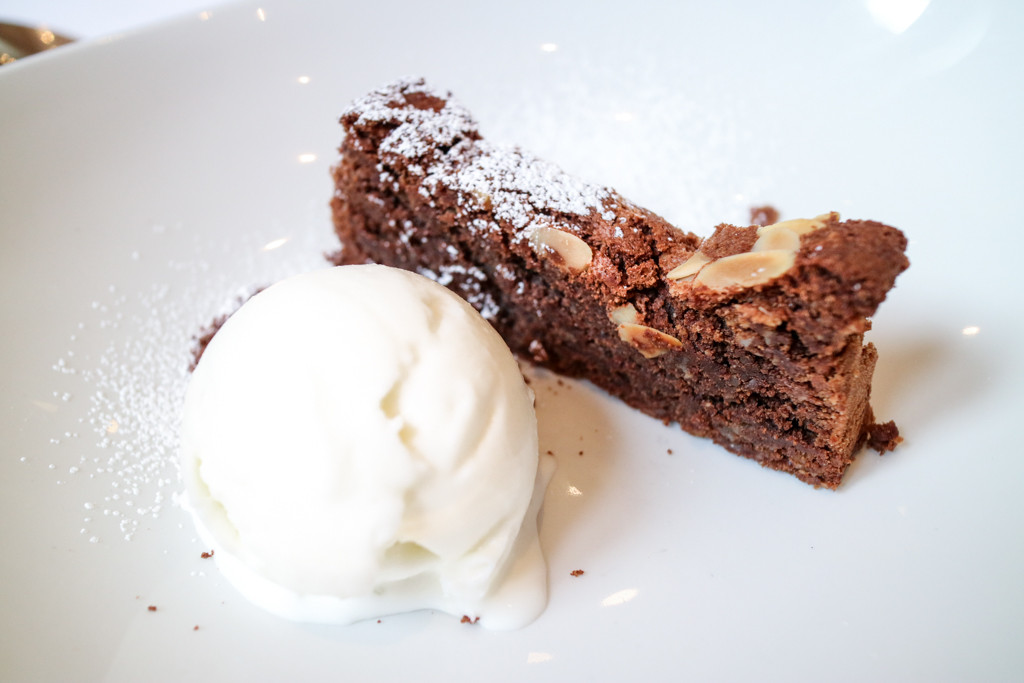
left=0, top=0, right=1024, bottom=681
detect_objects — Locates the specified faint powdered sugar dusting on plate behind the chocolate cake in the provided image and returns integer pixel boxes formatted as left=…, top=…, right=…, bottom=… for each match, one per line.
left=460, top=49, right=761, bottom=234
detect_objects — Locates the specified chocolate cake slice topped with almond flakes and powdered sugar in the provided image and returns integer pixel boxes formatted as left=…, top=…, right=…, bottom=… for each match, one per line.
left=332, top=80, right=908, bottom=488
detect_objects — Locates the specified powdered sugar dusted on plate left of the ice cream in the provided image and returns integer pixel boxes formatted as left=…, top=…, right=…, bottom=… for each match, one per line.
left=43, top=225, right=331, bottom=544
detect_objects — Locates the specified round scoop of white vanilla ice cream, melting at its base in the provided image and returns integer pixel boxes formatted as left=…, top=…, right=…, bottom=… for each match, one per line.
left=181, top=265, right=546, bottom=627
